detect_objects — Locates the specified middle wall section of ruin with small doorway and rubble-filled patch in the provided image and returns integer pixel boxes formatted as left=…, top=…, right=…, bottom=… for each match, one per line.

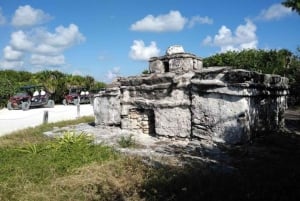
left=120, top=73, right=193, bottom=137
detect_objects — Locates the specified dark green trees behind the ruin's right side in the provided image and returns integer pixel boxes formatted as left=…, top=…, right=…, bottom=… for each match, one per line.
left=203, top=49, right=300, bottom=84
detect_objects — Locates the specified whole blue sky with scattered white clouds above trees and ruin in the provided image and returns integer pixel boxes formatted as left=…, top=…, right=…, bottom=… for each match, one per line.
left=0, top=0, right=300, bottom=82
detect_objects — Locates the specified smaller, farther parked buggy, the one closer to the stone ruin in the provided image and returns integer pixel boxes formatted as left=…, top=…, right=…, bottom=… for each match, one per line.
left=63, top=87, right=92, bottom=105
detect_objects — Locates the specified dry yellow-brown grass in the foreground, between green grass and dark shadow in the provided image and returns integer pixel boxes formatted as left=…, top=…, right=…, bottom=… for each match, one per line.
left=9, top=157, right=150, bottom=201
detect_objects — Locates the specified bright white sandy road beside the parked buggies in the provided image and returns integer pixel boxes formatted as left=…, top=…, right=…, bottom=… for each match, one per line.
left=0, top=104, right=94, bottom=136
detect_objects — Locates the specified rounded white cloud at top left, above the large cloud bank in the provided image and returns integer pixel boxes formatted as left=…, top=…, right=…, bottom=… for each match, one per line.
left=12, top=5, right=52, bottom=27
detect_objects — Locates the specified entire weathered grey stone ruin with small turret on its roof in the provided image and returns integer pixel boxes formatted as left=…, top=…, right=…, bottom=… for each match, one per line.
left=94, top=46, right=288, bottom=144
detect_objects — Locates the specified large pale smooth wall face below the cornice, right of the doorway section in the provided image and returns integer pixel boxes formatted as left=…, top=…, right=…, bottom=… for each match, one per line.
left=191, top=92, right=251, bottom=144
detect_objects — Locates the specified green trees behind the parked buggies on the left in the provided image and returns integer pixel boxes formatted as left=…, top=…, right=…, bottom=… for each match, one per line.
left=0, top=70, right=106, bottom=108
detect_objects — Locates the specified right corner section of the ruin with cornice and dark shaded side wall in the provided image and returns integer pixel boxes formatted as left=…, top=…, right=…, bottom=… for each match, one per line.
left=191, top=67, right=288, bottom=144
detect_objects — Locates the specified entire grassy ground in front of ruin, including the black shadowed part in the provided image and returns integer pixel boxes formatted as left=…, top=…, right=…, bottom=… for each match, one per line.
left=0, top=115, right=300, bottom=201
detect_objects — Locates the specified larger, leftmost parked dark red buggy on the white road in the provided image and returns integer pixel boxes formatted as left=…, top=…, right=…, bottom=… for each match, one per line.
left=7, top=85, right=55, bottom=110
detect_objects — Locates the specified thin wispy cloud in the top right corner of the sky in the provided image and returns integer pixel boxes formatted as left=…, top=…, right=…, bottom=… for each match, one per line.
left=257, top=4, right=292, bottom=21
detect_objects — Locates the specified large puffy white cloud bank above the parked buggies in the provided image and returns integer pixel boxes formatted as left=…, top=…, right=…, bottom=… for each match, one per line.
left=0, top=24, right=85, bottom=68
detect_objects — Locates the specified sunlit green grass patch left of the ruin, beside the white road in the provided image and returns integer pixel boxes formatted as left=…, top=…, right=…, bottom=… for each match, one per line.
left=0, top=130, right=118, bottom=200
